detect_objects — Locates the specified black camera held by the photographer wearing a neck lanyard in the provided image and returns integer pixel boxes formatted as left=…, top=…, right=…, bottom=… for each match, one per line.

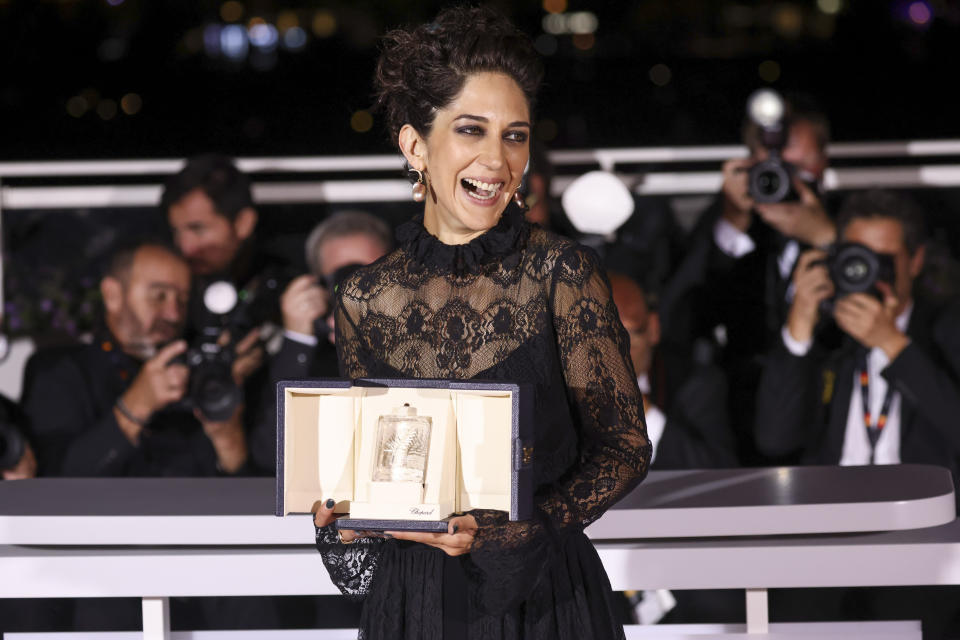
left=811, top=242, right=896, bottom=311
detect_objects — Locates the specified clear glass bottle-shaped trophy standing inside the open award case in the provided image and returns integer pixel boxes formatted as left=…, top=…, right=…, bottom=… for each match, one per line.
left=373, top=404, right=431, bottom=484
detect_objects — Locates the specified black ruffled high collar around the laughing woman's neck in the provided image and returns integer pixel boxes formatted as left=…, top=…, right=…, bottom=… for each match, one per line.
left=397, top=203, right=530, bottom=274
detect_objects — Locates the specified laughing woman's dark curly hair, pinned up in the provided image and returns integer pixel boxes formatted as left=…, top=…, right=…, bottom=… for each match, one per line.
left=375, top=6, right=543, bottom=142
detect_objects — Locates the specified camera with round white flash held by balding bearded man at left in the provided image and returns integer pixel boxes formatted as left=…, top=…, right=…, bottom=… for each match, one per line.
left=173, top=269, right=291, bottom=421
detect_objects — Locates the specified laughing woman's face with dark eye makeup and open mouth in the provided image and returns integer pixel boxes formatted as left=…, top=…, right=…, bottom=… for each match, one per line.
left=408, top=72, right=530, bottom=244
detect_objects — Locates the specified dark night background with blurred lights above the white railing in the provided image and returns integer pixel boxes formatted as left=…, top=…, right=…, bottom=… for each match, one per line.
left=0, top=0, right=960, bottom=160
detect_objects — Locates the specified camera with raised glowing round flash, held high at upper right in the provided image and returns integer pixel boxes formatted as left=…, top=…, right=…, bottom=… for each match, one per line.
left=747, top=89, right=812, bottom=204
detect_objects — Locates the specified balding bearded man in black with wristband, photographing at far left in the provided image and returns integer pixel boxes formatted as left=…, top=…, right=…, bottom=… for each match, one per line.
left=23, top=242, right=256, bottom=476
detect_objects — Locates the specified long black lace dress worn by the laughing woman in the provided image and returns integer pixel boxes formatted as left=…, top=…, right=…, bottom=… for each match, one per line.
left=317, top=206, right=650, bottom=640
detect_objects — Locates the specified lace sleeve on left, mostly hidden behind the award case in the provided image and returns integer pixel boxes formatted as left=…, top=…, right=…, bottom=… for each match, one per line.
left=316, top=297, right=383, bottom=599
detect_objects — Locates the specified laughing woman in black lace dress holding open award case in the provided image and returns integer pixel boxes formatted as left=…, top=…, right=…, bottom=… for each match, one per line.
left=315, top=7, right=650, bottom=640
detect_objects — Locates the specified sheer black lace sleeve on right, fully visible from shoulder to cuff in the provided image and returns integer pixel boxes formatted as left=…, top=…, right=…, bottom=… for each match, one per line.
left=471, top=245, right=652, bottom=609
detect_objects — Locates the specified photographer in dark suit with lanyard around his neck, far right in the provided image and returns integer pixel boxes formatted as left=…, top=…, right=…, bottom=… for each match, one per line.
left=755, top=191, right=960, bottom=484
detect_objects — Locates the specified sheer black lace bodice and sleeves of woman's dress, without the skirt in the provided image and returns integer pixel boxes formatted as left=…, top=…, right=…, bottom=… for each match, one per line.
left=318, top=209, right=650, bottom=636
